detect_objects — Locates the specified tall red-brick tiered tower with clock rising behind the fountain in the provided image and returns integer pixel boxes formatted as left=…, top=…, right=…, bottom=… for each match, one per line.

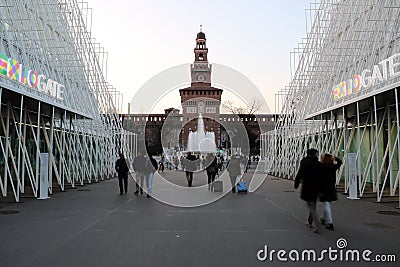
left=179, top=26, right=222, bottom=150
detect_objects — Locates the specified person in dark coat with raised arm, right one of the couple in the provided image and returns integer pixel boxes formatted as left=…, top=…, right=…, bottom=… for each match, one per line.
left=319, top=154, right=342, bottom=231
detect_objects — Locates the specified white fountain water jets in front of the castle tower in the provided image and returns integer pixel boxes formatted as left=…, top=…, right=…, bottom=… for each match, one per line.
left=187, top=113, right=217, bottom=155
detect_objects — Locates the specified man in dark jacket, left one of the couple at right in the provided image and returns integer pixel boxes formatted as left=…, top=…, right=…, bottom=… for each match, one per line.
left=294, top=148, right=322, bottom=233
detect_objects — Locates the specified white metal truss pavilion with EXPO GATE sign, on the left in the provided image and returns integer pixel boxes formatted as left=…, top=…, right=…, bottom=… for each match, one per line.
left=0, top=0, right=136, bottom=201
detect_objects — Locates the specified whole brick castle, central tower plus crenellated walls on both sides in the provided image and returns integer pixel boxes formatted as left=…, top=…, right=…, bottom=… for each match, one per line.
left=120, top=30, right=276, bottom=154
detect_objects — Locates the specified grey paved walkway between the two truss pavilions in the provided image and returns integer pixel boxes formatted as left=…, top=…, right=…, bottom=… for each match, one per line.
left=0, top=166, right=400, bottom=266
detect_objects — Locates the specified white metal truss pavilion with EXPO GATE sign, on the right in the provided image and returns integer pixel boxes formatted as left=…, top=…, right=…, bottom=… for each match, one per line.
left=261, top=0, right=400, bottom=204
